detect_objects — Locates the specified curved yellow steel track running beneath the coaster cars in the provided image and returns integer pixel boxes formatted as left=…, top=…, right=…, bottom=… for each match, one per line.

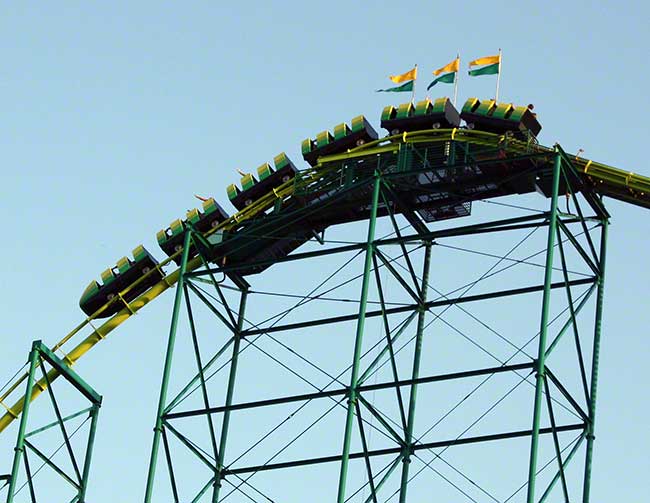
left=0, top=128, right=650, bottom=433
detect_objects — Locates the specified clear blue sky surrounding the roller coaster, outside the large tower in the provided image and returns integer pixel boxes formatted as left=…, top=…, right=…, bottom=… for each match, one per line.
left=0, top=0, right=650, bottom=503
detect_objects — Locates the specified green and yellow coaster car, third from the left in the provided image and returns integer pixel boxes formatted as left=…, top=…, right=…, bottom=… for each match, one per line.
left=226, top=152, right=298, bottom=211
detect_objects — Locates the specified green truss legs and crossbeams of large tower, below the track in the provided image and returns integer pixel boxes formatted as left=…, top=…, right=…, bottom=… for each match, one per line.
left=145, top=147, right=608, bottom=503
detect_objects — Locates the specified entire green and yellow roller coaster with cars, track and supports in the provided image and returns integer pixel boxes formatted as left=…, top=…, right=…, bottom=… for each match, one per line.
left=0, top=98, right=650, bottom=503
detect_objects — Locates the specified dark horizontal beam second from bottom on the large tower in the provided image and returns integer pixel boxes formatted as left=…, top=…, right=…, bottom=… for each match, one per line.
left=164, top=362, right=534, bottom=419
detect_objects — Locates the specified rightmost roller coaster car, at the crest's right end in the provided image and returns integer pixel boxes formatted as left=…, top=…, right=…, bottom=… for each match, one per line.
left=460, top=98, right=542, bottom=138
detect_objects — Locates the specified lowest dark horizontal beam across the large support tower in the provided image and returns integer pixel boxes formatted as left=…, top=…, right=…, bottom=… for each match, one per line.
left=222, top=423, right=586, bottom=476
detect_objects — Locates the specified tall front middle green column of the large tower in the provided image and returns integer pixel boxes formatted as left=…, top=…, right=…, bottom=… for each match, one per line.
left=336, top=173, right=382, bottom=503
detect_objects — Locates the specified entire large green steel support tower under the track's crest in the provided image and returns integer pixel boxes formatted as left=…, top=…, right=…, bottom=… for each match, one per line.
left=140, top=144, right=609, bottom=503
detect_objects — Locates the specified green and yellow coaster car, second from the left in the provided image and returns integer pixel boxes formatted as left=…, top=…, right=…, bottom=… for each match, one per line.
left=156, top=198, right=228, bottom=265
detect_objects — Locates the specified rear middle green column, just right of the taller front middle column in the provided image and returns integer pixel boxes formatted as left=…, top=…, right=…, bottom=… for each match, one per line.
left=399, top=242, right=431, bottom=503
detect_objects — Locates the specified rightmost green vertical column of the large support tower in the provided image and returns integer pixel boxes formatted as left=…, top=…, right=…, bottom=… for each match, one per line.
left=582, top=220, right=609, bottom=503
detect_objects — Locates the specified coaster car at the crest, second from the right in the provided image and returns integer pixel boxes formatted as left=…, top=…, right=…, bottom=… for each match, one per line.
left=381, top=98, right=460, bottom=135
